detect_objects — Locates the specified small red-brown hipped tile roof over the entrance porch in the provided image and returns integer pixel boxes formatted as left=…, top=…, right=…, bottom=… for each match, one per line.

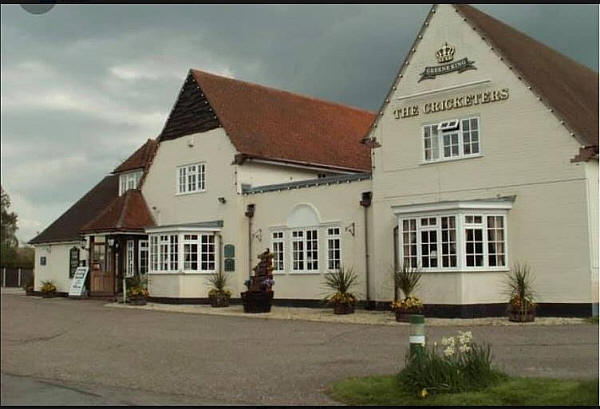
left=80, top=189, right=155, bottom=233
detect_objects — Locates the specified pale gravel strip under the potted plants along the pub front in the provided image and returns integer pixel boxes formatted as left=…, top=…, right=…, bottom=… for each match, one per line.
left=105, top=303, right=587, bottom=327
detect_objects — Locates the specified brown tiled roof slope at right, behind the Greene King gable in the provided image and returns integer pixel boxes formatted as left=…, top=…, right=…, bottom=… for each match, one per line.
left=454, top=4, right=598, bottom=146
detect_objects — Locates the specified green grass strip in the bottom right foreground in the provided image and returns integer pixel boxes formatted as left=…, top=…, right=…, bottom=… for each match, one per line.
left=328, top=375, right=598, bottom=406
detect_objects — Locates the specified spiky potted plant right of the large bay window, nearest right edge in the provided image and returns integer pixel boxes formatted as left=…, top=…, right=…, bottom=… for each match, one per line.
left=505, top=263, right=536, bottom=322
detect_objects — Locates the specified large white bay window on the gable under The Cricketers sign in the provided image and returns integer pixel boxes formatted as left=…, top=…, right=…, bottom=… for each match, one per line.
left=393, top=197, right=514, bottom=271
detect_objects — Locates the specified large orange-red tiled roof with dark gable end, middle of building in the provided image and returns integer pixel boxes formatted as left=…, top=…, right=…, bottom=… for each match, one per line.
left=159, top=70, right=375, bottom=171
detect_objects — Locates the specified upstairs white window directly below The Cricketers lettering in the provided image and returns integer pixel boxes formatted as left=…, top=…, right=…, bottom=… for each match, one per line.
left=423, top=117, right=481, bottom=162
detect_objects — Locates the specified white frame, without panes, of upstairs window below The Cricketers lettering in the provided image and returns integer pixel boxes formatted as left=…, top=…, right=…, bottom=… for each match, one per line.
left=421, top=115, right=483, bottom=164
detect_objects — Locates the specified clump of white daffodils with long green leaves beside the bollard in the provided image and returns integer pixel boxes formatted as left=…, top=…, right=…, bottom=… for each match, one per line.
left=397, top=331, right=506, bottom=398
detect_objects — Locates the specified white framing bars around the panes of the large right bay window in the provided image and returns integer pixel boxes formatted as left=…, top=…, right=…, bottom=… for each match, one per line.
left=397, top=209, right=510, bottom=273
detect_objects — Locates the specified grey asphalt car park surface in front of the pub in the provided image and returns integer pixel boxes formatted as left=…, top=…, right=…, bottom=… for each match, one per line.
left=1, top=294, right=598, bottom=405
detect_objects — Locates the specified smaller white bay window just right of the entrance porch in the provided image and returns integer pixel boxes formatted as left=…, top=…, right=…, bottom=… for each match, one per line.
left=150, top=232, right=217, bottom=273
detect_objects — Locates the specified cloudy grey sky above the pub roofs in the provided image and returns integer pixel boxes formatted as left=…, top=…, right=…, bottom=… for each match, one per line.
left=1, top=4, right=598, bottom=241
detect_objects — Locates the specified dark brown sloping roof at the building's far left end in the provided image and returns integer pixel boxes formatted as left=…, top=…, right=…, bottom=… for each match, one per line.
left=29, top=175, right=119, bottom=244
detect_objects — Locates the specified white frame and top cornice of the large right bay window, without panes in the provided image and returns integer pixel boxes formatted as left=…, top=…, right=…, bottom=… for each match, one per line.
left=394, top=203, right=512, bottom=272
